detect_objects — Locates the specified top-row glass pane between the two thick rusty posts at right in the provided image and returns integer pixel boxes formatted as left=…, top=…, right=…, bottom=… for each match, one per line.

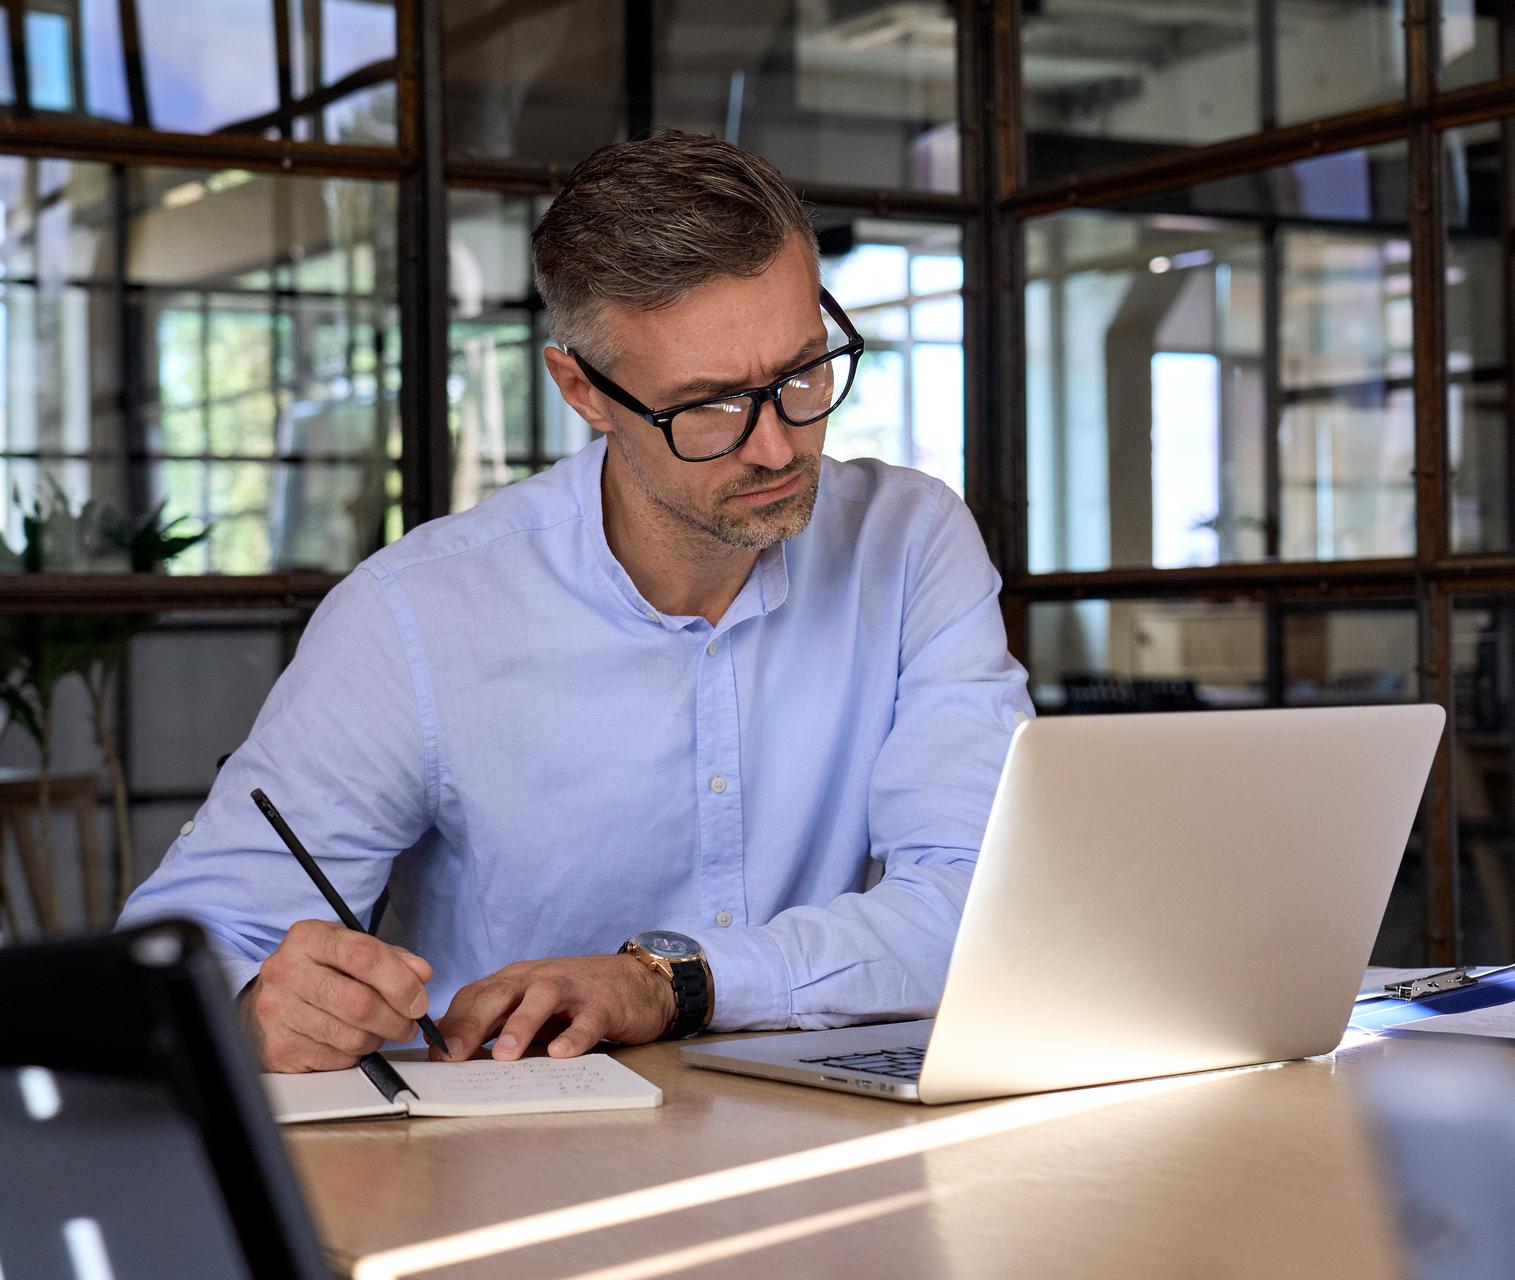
left=1021, top=0, right=1404, bottom=182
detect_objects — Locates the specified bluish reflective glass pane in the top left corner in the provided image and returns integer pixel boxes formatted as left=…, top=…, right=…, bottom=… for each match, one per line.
left=26, top=0, right=397, bottom=145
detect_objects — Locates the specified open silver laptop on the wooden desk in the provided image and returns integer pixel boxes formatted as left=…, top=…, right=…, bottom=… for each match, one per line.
left=682, top=706, right=1445, bottom=1103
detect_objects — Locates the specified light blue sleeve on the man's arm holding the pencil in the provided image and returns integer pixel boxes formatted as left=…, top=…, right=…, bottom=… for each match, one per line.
left=120, top=568, right=435, bottom=989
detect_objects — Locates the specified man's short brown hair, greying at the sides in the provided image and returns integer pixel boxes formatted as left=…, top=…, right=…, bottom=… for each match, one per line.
left=532, top=129, right=820, bottom=368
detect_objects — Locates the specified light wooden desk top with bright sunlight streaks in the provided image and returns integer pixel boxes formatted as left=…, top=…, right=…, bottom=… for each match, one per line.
left=275, top=1038, right=1478, bottom=1280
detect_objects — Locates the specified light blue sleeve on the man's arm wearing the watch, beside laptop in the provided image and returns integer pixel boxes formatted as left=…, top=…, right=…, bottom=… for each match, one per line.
left=697, top=494, right=1032, bottom=1030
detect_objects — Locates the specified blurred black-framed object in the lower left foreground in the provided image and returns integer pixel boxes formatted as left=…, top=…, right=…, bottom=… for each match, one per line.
left=0, top=921, right=332, bottom=1280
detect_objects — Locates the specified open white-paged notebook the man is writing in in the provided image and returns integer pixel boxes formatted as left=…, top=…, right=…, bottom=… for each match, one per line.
left=264, top=1053, right=662, bottom=1124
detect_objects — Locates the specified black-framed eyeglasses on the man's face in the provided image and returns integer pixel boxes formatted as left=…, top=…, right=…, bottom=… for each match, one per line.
left=568, top=289, right=864, bottom=462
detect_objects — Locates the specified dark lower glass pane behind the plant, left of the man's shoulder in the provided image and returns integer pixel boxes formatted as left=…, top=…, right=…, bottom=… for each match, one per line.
left=0, top=609, right=305, bottom=935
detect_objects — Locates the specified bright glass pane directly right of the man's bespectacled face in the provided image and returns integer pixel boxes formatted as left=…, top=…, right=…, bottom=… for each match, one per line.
left=820, top=218, right=964, bottom=494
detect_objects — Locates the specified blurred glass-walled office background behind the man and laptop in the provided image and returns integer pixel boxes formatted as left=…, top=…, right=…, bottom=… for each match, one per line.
left=0, top=0, right=1515, bottom=963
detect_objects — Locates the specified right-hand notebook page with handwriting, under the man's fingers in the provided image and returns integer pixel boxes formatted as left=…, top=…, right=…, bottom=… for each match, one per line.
left=394, top=1053, right=662, bottom=1115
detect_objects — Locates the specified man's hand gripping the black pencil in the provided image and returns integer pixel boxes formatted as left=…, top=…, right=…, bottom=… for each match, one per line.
left=241, top=919, right=432, bottom=1071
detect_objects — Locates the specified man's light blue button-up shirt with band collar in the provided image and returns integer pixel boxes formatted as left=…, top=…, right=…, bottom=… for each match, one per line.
left=121, top=441, right=1030, bottom=1030
